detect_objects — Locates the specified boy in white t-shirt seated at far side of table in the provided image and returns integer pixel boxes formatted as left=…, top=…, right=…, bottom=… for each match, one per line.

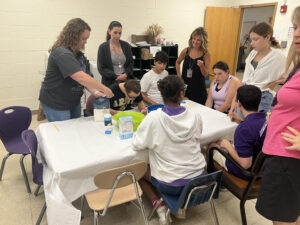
left=141, top=51, right=169, bottom=105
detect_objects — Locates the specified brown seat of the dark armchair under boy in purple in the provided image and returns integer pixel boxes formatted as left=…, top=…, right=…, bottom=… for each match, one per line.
left=214, top=162, right=261, bottom=199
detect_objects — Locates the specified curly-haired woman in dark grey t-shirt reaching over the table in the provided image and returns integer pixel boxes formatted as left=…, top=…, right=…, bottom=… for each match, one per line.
left=39, top=18, right=113, bottom=122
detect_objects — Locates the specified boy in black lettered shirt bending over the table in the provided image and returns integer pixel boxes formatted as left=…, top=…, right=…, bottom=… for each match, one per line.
left=94, top=79, right=147, bottom=115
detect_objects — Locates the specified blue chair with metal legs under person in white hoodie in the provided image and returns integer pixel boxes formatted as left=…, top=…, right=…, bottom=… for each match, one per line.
left=149, top=171, right=222, bottom=224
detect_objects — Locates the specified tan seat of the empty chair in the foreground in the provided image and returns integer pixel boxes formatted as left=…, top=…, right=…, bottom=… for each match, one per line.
left=85, top=183, right=143, bottom=211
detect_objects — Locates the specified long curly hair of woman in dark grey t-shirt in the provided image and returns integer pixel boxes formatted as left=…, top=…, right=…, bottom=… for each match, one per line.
left=48, top=18, right=91, bottom=52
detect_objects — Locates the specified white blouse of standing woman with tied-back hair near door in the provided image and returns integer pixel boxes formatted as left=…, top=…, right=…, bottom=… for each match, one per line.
left=243, top=48, right=286, bottom=95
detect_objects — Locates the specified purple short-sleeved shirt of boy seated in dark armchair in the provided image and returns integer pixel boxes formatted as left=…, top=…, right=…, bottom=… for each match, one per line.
left=226, top=112, right=267, bottom=178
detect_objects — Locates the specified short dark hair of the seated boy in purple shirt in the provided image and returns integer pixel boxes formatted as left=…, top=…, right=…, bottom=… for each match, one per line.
left=236, top=85, right=261, bottom=111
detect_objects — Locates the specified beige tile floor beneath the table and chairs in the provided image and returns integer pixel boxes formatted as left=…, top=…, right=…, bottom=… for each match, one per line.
left=0, top=115, right=271, bottom=225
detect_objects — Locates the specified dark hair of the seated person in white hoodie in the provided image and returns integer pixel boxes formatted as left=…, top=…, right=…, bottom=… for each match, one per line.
left=157, top=75, right=184, bottom=103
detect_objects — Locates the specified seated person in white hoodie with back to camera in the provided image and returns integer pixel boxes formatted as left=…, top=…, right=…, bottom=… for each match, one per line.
left=132, top=76, right=206, bottom=224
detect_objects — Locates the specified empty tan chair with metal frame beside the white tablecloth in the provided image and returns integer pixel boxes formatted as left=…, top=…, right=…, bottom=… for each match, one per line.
left=82, top=162, right=148, bottom=225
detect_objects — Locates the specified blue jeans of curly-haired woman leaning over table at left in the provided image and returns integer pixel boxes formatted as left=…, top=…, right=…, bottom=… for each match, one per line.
left=42, top=103, right=81, bottom=122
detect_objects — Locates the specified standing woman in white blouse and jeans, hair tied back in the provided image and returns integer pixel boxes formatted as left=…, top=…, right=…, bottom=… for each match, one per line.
left=229, top=22, right=286, bottom=116
